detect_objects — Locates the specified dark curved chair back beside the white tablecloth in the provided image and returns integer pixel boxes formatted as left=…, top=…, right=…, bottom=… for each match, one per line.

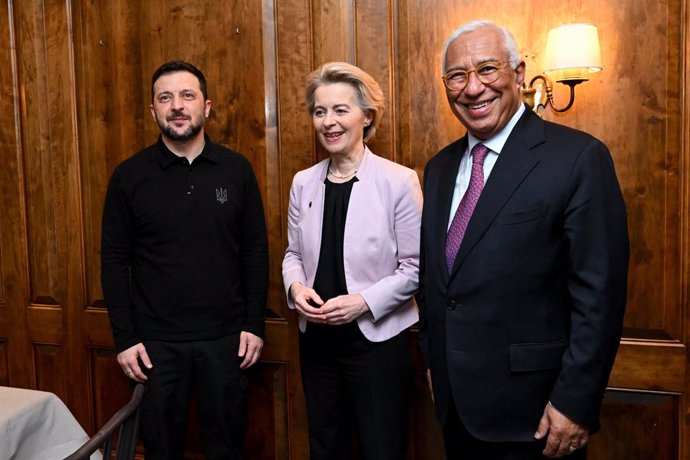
left=65, top=383, right=144, bottom=460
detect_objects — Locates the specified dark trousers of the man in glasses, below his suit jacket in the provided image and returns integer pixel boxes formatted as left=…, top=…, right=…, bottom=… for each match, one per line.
left=443, top=398, right=587, bottom=460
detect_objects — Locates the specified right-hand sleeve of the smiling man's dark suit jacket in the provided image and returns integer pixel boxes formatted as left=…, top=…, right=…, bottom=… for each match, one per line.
left=550, top=140, right=629, bottom=430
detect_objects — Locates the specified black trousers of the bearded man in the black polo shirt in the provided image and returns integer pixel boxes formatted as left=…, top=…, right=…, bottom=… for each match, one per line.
left=140, top=333, right=248, bottom=460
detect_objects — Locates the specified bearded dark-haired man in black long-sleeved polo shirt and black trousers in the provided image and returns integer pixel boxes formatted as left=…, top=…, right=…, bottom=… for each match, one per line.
left=101, top=61, right=268, bottom=459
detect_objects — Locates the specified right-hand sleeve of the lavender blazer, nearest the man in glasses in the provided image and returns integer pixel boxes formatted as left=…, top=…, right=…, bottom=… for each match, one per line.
left=360, top=168, right=422, bottom=322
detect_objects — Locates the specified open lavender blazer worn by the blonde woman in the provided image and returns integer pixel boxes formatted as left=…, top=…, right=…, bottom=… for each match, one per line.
left=283, top=148, right=422, bottom=342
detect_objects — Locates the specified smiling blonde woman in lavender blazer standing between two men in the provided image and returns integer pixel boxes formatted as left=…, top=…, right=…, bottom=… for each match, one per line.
left=283, top=62, right=422, bottom=460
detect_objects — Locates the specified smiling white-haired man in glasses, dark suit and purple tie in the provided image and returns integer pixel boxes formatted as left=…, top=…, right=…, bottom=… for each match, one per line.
left=419, top=21, right=628, bottom=460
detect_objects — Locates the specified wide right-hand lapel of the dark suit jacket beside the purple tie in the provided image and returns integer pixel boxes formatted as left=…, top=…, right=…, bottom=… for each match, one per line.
left=444, top=109, right=544, bottom=278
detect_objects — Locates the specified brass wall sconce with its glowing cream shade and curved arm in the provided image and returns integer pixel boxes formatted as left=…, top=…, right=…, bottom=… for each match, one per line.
left=522, top=24, right=601, bottom=112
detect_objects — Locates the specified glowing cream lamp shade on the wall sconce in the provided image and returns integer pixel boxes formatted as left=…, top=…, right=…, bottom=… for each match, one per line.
left=544, top=24, right=601, bottom=81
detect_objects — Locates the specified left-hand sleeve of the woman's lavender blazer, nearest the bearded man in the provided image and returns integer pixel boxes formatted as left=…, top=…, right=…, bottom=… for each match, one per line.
left=283, top=176, right=307, bottom=309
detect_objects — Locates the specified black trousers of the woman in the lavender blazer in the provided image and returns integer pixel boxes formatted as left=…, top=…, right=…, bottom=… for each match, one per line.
left=300, top=323, right=412, bottom=460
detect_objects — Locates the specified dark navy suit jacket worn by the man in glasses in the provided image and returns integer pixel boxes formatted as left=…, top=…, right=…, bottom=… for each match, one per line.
left=419, top=109, right=628, bottom=442
